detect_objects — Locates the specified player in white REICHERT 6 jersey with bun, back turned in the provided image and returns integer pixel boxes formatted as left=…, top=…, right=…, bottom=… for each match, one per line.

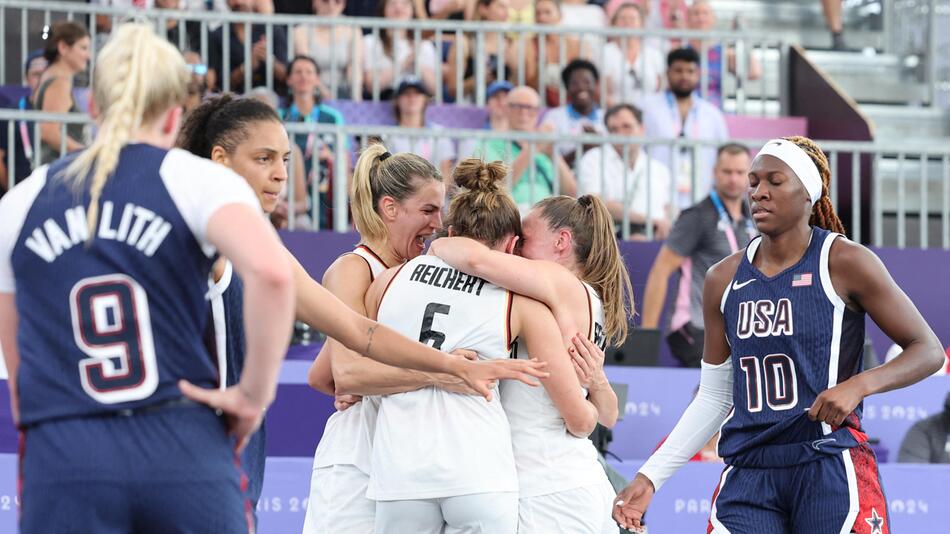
left=366, top=159, right=597, bottom=534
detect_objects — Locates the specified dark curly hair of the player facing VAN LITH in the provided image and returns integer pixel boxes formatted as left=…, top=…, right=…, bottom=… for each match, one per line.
left=175, top=93, right=280, bottom=159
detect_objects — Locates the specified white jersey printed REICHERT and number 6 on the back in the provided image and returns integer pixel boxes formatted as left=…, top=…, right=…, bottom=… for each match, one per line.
left=367, top=256, right=518, bottom=501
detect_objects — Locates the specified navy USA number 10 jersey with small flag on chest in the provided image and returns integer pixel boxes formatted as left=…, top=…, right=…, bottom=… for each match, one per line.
left=719, top=228, right=867, bottom=467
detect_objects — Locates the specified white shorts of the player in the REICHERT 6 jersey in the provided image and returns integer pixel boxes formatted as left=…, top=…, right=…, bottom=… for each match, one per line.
left=376, top=491, right=518, bottom=534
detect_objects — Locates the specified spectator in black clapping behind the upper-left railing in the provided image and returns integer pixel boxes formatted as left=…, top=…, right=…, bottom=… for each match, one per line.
left=208, top=0, right=287, bottom=94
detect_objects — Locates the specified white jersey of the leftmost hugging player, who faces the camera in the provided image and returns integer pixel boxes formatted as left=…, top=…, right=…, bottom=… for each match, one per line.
left=313, top=245, right=388, bottom=475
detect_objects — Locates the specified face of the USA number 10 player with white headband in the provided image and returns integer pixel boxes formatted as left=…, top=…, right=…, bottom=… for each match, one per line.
left=749, top=155, right=812, bottom=235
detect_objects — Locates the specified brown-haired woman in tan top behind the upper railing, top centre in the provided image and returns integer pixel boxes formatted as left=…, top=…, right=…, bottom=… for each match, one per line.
left=528, top=0, right=582, bottom=107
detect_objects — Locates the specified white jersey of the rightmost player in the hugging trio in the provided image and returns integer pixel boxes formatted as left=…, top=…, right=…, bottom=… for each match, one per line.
left=501, top=284, right=606, bottom=498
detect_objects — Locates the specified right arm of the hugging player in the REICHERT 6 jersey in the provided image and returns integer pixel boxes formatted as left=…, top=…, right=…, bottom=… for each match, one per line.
left=511, top=295, right=597, bottom=438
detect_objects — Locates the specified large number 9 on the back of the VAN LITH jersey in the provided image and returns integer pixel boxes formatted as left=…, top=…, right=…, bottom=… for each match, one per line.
left=69, top=274, right=158, bottom=404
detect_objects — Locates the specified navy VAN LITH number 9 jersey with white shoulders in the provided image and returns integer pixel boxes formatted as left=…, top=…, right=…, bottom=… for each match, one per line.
left=0, top=144, right=259, bottom=424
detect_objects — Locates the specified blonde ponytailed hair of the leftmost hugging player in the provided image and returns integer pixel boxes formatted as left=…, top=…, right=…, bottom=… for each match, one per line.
left=350, top=143, right=442, bottom=242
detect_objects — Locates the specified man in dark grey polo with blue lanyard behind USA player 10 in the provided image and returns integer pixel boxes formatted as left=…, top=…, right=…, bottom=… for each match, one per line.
left=643, top=143, right=756, bottom=367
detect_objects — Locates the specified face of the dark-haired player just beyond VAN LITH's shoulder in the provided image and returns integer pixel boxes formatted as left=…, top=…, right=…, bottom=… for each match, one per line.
left=220, top=121, right=290, bottom=213
